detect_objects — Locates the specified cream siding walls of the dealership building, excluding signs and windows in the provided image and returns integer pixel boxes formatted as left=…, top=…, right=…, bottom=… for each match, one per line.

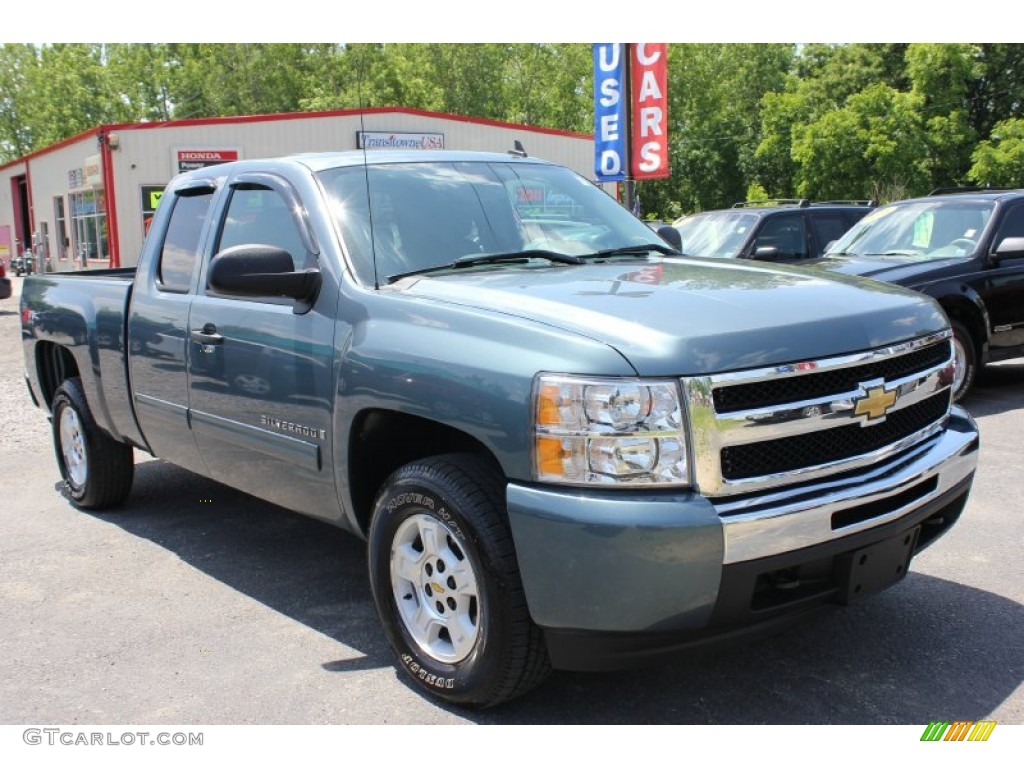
left=0, top=111, right=594, bottom=271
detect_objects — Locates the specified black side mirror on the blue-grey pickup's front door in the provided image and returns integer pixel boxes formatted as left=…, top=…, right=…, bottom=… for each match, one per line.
left=209, top=244, right=321, bottom=312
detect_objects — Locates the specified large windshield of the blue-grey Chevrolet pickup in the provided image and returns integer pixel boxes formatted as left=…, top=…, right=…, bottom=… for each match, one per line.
left=319, top=161, right=666, bottom=285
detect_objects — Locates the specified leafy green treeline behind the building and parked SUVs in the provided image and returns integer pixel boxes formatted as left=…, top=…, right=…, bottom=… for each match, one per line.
left=6, top=43, right=1024, bottom=218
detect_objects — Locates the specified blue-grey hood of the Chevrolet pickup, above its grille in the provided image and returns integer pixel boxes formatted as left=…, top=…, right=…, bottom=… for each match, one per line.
left=391, top=258, right=947, bottom=376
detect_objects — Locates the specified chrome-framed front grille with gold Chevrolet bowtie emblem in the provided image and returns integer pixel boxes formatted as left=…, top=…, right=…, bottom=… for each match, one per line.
left=683, top=332, right=952, bottom=496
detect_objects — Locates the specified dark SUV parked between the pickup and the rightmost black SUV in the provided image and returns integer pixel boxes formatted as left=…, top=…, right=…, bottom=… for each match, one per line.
left=658, top=200, right=872, bottom=262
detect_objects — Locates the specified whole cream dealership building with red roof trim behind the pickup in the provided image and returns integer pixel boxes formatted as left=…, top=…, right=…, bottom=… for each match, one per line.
left=0, top=108, right=594, bottom=271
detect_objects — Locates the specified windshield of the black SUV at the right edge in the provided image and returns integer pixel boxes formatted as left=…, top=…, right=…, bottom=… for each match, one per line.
left=826, top=199, right=993, bottom=259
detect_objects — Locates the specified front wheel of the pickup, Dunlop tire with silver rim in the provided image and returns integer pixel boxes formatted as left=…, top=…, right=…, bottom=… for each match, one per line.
left=369, top=454, right=551, bottom=708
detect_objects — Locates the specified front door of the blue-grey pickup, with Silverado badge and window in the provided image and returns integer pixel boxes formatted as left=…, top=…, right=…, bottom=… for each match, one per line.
left=187, top=171, right=339, bottom=519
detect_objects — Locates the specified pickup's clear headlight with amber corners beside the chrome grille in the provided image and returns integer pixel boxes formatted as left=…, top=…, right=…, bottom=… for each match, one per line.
left=534, top=374, right=689, bottom=485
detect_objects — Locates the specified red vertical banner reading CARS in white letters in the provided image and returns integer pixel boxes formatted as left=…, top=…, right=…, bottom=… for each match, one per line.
left=630, top=43, right=670, bottom=179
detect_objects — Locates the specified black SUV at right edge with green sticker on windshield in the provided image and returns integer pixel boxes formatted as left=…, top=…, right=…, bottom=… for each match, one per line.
left=813, top=189, right=1024, bottom=400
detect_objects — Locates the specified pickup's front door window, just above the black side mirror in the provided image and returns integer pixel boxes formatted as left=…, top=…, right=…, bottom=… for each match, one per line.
left=217, top=187, right=307, bottom=269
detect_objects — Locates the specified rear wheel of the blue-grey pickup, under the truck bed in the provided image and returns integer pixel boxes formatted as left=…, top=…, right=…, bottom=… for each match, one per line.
left=52, top=378, right=135, bottom=510
